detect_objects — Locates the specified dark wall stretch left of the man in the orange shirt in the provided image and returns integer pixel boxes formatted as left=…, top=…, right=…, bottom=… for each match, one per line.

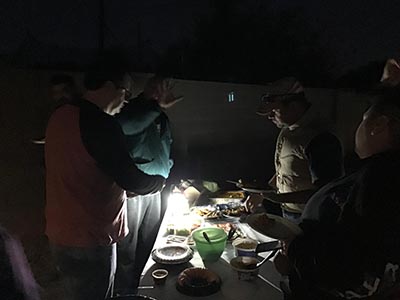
left=0, top=65, right=79, bottom=241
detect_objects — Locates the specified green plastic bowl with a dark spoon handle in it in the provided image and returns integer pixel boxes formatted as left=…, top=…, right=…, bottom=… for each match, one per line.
left=192, top=227, right=228, bottom=262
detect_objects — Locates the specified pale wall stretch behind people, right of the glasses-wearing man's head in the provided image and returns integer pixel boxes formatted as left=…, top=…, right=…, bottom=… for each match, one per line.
left=130, top=74, right=368, bottom=183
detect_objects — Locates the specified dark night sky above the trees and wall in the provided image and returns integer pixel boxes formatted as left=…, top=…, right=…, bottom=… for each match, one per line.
left=0, top=0, right=400, bottom=76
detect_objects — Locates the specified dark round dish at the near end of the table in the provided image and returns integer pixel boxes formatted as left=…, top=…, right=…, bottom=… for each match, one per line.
left=176, top=267, right=221, bottom=296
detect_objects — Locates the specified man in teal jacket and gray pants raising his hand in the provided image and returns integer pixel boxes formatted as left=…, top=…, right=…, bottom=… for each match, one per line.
left=116, top=77, right=182, bottom=294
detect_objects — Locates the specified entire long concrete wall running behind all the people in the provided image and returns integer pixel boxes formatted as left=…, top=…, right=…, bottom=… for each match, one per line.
left=0, top=67, right=367, bottom=240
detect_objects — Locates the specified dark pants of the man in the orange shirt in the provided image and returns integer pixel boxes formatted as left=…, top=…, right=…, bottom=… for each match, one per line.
left=52, top=244, right=117, bottom=300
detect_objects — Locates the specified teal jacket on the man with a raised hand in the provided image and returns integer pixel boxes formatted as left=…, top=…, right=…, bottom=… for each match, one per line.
left=115, top=94, right=173, bottom=178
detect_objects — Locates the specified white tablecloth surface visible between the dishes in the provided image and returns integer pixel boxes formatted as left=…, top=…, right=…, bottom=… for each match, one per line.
left=138, top=206, right=283, bottom=300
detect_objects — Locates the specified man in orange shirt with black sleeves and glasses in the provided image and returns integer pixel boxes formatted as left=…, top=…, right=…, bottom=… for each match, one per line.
left=45, top=59, right=165, bottom=300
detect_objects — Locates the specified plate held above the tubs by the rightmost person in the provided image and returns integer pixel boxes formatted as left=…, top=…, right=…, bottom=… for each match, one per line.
left=246, top=213, right=303, bottom=241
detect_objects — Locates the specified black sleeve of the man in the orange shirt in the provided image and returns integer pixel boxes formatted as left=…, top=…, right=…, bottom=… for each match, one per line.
left=80, top=105, right=165, bottom=195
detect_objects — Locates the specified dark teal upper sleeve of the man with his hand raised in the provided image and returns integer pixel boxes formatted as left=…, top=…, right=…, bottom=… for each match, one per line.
left=115, top=99, right=162, bottom=135
